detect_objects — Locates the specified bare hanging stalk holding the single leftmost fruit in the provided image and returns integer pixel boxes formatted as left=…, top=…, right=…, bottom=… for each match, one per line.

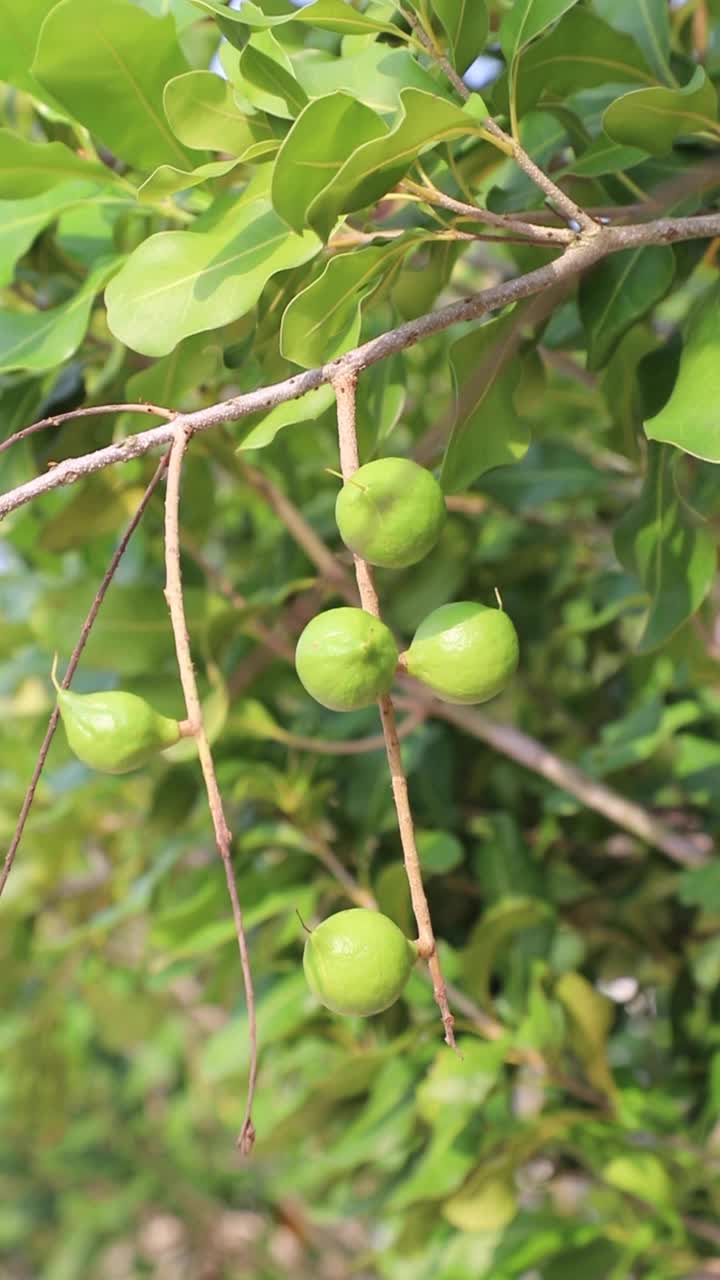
left=165, top=426, right=258, bottom=1156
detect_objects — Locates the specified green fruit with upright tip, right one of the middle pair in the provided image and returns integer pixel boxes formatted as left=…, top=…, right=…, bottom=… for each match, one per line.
left=402, top=600, right=518, bottom=703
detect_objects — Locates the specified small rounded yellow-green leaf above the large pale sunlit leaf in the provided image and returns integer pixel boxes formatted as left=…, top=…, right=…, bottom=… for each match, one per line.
left=163, top=72, right=270, bottom=157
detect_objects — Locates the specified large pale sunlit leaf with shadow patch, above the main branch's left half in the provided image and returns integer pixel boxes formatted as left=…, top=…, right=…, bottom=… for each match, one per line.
left=105, top=198, right=318, bottom=356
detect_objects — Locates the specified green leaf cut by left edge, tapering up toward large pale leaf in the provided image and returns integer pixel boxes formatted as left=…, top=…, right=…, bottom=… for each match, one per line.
left=0, top=259, right=120, bottom=374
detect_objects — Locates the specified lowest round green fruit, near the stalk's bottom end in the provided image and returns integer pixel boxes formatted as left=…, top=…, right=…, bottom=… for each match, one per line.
left=302, top=906, right=418, bottom=1018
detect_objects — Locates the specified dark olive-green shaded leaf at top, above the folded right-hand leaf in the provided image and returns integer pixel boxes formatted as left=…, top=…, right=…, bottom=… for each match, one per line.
left=509, top=9, right=655, bottom=111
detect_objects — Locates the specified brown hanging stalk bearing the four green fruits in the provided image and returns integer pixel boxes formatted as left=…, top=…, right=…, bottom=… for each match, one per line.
left=333, top=371, right=456, bottom=1048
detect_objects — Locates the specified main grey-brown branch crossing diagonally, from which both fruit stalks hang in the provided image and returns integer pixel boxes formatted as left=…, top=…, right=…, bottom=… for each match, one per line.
left=0, top=214, right=720, bottom=518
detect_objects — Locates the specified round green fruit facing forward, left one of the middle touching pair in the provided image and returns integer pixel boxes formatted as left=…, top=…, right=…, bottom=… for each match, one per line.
left=295, top=608, right=397, bottom=712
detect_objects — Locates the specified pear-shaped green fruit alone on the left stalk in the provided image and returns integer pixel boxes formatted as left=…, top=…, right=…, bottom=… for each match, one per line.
left=58, top=689, right=181, bottom=773
